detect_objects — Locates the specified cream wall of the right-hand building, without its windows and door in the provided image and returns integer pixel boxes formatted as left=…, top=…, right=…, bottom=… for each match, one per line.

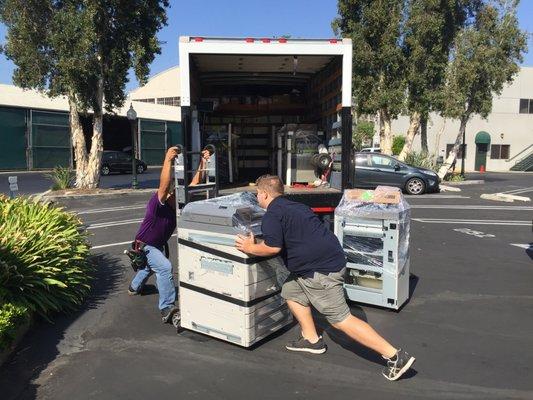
left=392, top=67, right=533, bottom=171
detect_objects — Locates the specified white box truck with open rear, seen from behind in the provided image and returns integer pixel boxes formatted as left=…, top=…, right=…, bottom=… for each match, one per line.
left=179, top=36, right=354, bottom=214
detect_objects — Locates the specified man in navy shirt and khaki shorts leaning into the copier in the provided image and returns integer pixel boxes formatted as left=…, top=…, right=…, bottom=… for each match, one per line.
left=235, top=175, right=415, bottom=381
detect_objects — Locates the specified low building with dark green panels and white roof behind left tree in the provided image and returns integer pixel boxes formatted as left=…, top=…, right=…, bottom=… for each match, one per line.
left=0, top=85, right=182, bottom=170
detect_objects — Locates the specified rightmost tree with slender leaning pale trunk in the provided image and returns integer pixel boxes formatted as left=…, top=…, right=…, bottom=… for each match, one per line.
left=439, top=0, right=527, bottom=178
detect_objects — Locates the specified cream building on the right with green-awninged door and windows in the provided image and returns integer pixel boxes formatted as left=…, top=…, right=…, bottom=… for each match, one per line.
left=392, top=67, right=533, bottom=171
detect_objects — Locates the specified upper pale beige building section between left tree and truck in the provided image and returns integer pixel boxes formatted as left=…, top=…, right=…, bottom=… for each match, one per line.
left=130, top=66, right=180, bottom=106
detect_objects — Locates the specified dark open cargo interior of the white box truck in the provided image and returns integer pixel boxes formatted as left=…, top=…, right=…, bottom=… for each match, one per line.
left=189, top=54, right=342, bottom=187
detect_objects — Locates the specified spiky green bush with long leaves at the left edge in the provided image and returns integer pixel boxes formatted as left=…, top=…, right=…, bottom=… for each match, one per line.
left=0, top=196, right=92, bottom=318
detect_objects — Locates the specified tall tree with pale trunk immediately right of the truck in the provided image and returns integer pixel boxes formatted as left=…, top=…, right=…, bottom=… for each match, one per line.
left=332, top=0, right=406, bottom=154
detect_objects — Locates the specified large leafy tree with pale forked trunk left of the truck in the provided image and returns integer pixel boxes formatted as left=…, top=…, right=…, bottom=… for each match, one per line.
left=0, top=0, right=169, bottom=188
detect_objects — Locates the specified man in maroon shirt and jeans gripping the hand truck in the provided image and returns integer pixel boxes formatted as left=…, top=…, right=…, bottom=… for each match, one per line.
left=128, top=147, right=209, bottom=323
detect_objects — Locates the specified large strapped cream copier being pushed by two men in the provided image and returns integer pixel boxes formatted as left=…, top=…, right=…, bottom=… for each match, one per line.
left=178, top=192, right=292, bottom=347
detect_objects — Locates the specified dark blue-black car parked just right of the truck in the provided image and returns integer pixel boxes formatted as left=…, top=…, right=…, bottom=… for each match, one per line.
left=355, top=153, right=440, bottom=194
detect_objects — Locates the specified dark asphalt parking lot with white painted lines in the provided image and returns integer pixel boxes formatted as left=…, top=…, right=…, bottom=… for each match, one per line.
left=0, top=174, right=533, bottom=400
